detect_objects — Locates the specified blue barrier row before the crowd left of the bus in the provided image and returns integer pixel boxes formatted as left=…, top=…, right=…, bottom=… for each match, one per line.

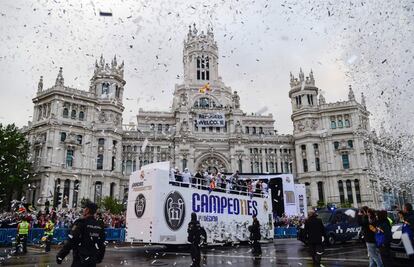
left=0, top=228, right=125, bottom=245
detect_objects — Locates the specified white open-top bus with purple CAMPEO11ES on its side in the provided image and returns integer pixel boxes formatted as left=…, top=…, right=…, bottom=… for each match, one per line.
left=126, top=162, right=306, bottom=244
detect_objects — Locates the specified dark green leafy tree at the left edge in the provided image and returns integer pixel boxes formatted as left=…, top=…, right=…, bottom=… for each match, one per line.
left=0, top=124, right=32, bottom=213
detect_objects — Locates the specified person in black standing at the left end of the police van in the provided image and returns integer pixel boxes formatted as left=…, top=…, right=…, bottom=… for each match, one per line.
left=305, top=211, right=325, bottom=266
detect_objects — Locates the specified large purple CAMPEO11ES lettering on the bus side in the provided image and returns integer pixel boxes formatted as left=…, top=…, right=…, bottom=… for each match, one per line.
left=192, top=193, right=257, bottom=216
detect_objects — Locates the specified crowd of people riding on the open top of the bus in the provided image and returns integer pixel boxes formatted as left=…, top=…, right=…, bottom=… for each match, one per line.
left=170, top=167, right=269, bottom=197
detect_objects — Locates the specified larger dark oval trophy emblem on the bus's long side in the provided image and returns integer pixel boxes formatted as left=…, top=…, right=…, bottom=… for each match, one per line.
left=164, top=191, right=185, bottom=231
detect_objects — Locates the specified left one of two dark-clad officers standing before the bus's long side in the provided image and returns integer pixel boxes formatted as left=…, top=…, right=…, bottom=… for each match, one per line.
left=187, top=212, right=202, bottom=267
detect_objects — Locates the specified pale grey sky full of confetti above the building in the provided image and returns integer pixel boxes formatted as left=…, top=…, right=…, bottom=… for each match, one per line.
left=0, top=0, right=413, bottom=133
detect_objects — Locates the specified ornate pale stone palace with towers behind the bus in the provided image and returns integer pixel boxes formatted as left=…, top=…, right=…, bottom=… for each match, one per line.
left=26, top=25, right=412, bottom=210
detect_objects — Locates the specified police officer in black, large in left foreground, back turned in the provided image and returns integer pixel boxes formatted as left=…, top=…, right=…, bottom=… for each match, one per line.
left=56, top=201, right=105, bottom=267
